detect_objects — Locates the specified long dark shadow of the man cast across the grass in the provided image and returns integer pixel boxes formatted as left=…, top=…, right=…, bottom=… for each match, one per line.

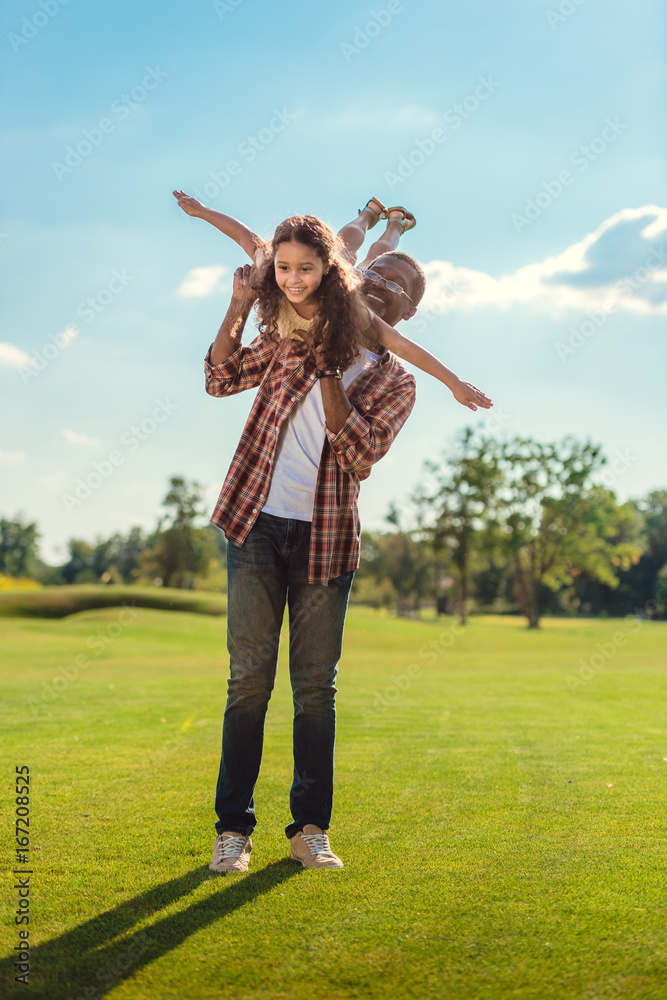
left=0, top=858, right=302, bottom=1000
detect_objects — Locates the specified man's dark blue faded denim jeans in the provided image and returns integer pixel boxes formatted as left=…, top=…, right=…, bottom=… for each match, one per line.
left=215, top=513, right=354, bottom=837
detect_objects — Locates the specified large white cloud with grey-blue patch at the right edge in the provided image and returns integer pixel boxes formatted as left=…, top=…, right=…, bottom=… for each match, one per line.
left=423, top=205, right=667, bottom=313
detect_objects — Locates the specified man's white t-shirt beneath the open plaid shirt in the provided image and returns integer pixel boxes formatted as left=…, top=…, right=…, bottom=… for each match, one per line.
left=262, top=348, right=380, bottom=521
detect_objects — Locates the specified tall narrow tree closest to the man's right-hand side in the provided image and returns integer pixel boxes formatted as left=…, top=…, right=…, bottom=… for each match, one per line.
left=413, top=427, right=502, bottom=625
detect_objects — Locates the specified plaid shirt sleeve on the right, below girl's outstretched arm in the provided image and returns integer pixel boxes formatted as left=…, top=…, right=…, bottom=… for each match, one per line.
left=326, top=372, right=416, bottom=479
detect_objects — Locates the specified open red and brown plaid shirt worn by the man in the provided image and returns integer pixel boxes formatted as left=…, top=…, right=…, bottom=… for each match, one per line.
left=204, top=336, right=415, bottom=584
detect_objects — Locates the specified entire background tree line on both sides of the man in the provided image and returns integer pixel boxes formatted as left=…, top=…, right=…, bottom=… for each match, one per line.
left=0, top=428, right=667, bottom=628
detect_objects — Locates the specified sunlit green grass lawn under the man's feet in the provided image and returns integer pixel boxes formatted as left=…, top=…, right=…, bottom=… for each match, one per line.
left=0, top=608, right=667, bottom=1000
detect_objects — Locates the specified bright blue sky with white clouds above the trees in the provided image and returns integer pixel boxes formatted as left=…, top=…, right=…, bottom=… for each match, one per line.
left=0, top=0, right=667, bottom=560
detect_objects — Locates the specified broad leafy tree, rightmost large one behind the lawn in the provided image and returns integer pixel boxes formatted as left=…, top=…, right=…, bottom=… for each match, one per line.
left=500, top=438, right=641, bottom=628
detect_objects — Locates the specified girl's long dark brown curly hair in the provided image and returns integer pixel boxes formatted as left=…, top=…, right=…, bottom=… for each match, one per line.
left=255, top=215, right=367, bottom=369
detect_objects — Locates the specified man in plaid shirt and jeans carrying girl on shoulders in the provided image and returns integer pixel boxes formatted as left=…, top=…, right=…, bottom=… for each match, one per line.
left=205, top=248, right=423, bottom=872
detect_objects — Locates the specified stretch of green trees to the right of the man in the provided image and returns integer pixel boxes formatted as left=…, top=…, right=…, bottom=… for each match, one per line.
left=355, top=428, right=667, bottom=628
